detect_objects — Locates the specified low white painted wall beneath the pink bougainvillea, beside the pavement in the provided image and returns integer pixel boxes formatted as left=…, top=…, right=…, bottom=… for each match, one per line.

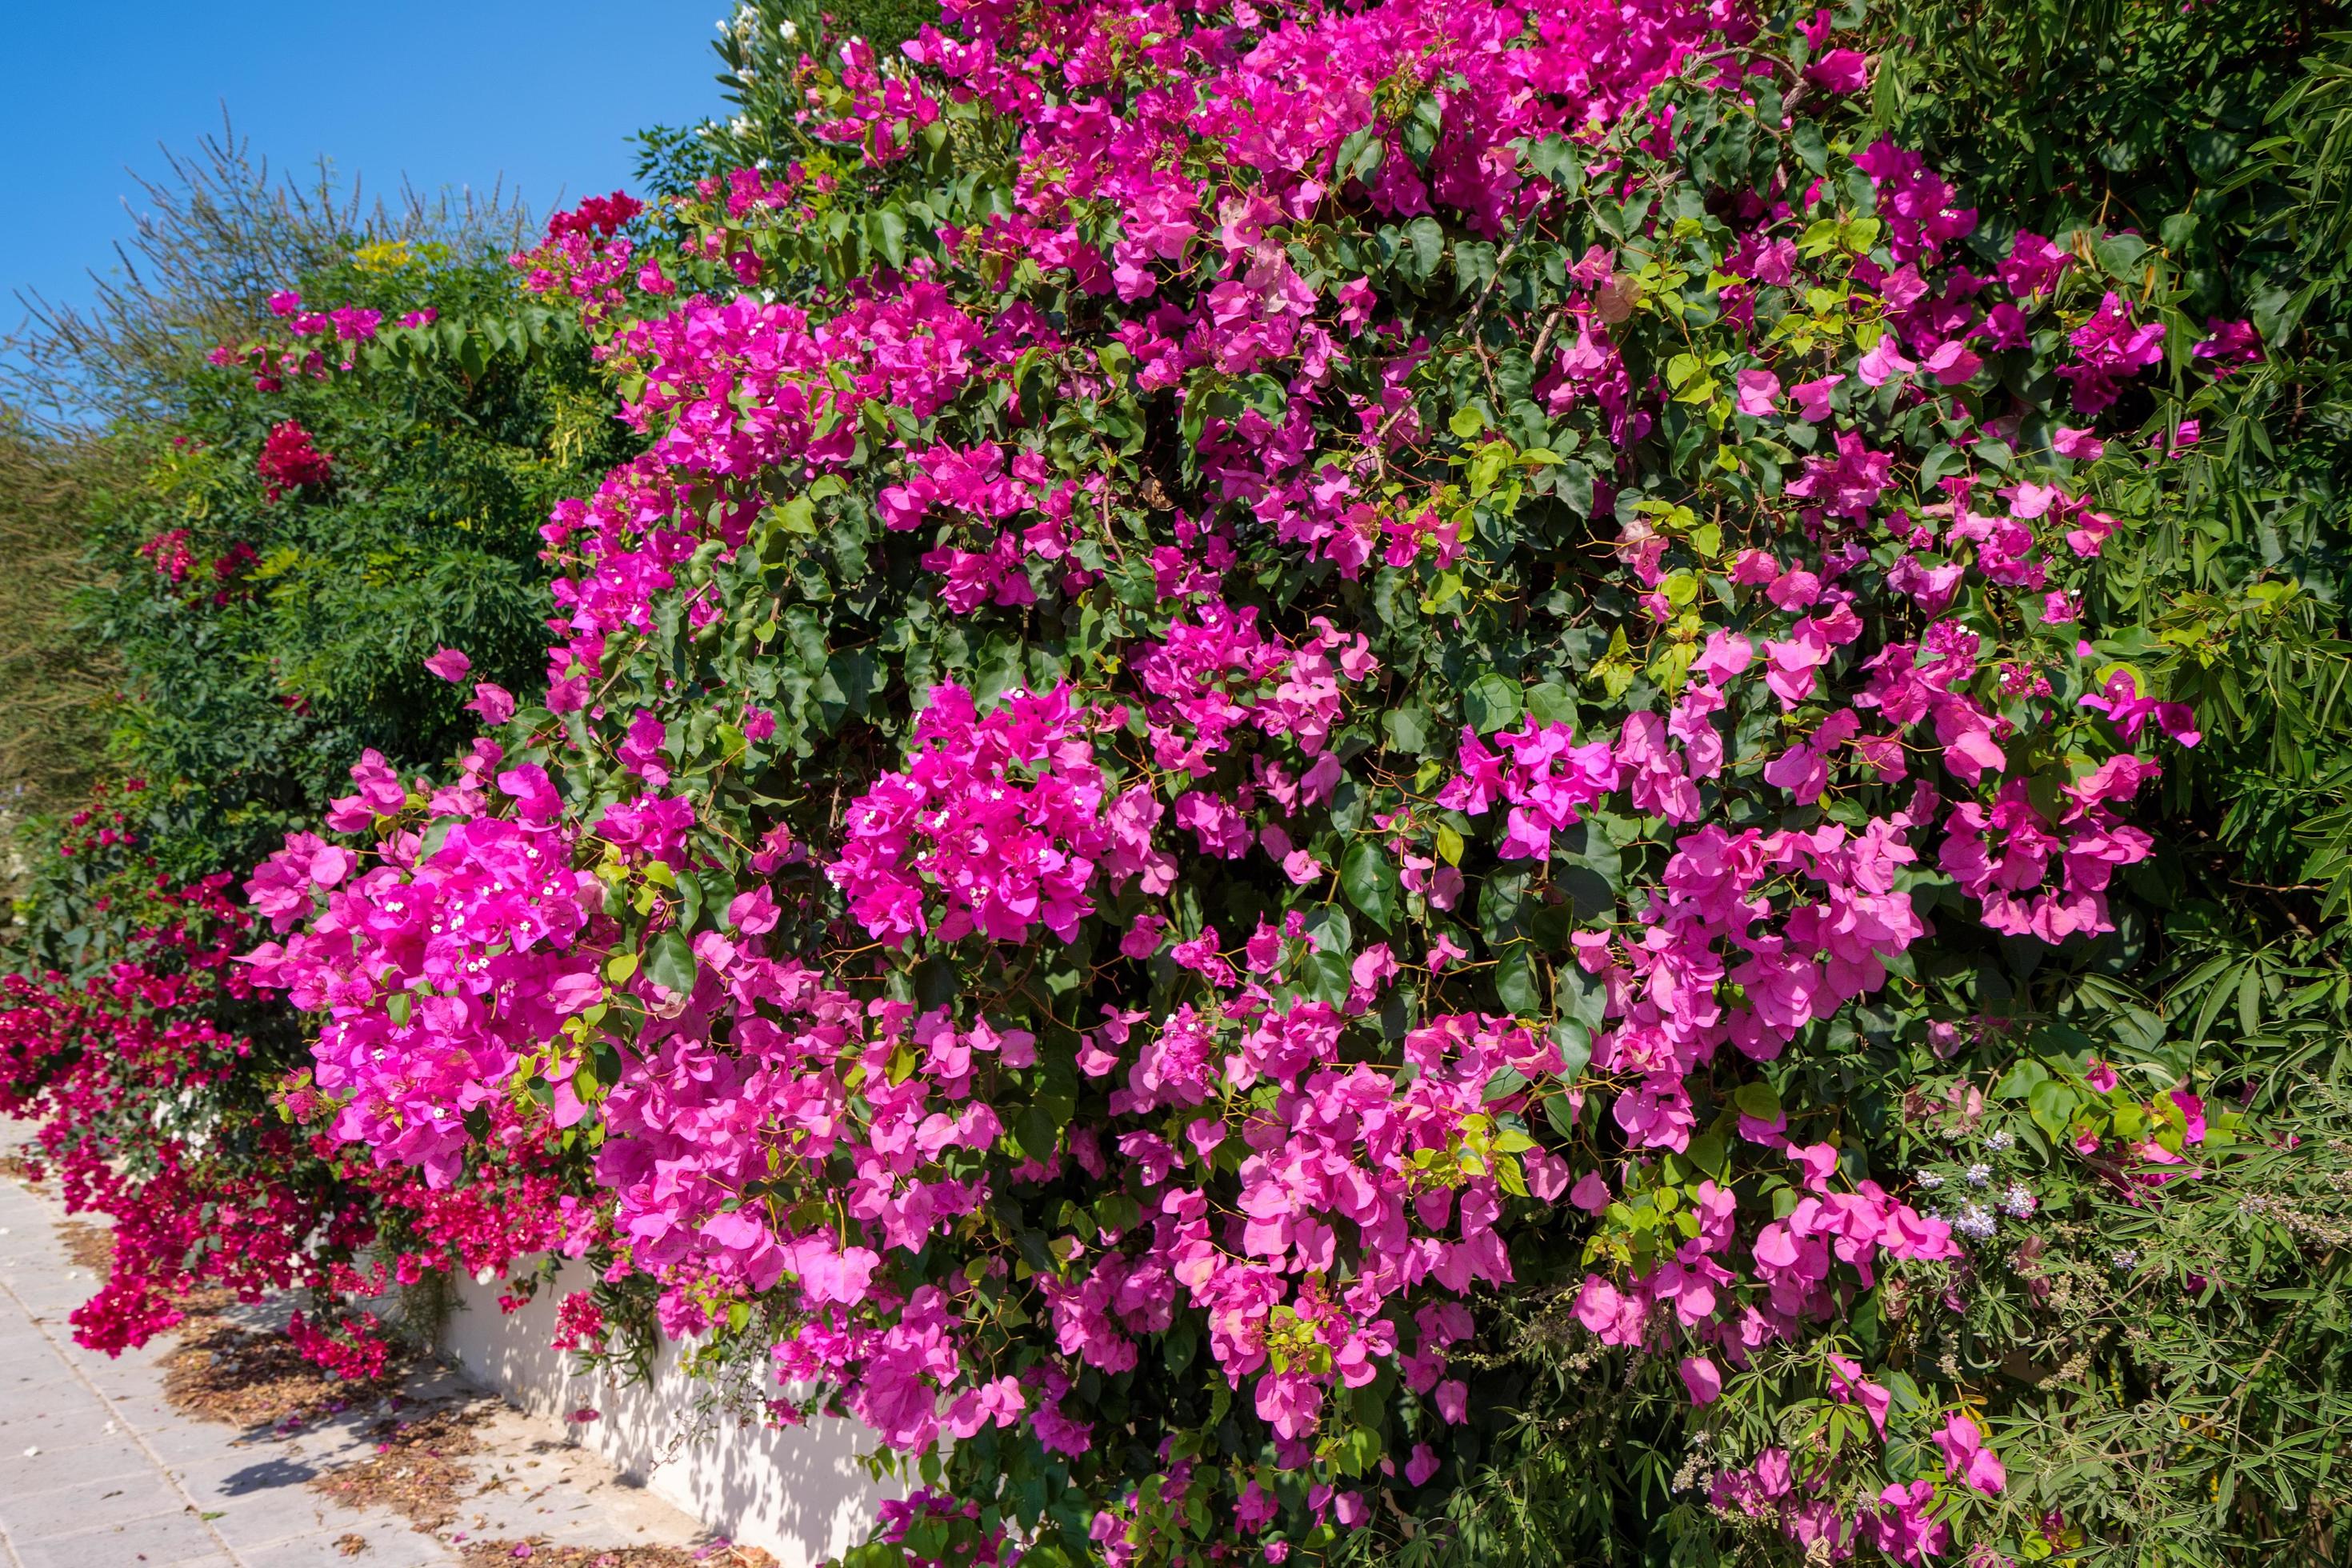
left=442, top=1262, right=898, bottom=1568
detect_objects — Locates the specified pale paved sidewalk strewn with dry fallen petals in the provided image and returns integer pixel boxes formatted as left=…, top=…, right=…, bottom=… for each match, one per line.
left=0, top=1124, right=726, bottom=1568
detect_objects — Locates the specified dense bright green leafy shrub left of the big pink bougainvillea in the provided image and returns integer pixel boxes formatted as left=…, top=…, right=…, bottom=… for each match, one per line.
left=92, top=268, right=614, bottom=893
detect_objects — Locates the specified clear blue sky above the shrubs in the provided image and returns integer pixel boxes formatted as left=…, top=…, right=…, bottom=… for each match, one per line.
left=0, top=0, right=734, bottom=334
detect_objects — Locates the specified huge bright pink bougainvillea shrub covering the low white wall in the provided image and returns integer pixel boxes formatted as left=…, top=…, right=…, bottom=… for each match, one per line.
left=18, top=0, right=2326, bottom=1568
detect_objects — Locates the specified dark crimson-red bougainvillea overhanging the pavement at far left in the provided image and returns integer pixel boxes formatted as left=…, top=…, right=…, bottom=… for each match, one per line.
left=0, top=781, right=578, bottom=1378
